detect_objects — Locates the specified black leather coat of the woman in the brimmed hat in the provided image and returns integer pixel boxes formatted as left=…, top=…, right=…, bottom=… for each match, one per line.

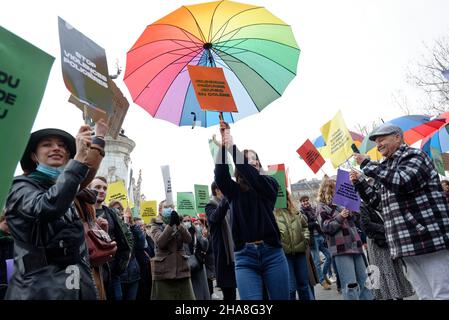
left=5, top=160, right=97, bottom=300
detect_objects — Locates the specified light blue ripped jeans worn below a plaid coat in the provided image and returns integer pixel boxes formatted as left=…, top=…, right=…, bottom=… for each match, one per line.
left=334, top=254, right=374, bottom=300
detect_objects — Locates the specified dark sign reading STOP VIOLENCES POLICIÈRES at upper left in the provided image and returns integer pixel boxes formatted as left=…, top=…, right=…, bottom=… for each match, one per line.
left=58, top=17, right=112, bottom=114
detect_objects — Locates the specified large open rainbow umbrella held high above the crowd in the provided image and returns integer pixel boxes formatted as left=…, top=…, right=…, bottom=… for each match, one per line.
left=124, top=1, right=300, bottom=127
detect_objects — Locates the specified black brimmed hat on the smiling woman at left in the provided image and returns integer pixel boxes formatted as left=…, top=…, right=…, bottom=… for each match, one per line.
left=20, top=128, right=76, bottom=172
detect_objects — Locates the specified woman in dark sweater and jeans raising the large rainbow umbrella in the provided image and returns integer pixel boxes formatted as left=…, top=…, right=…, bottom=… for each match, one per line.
left=215, top=120, right=289, bottom=300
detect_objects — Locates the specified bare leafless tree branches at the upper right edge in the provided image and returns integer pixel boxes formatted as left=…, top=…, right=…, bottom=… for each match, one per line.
left=407, top=37, right=449, bottom=115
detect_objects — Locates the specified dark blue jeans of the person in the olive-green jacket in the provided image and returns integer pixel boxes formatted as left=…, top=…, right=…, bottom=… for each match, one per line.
left=285, top=253, right=315, bottom=300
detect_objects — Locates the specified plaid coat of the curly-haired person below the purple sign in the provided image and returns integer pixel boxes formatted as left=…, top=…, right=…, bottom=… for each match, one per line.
left=317, top=203, right=363, bottom=256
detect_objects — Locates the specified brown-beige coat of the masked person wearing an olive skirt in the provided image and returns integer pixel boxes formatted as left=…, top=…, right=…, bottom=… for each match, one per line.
left=150, top=217, right=192, bottom=280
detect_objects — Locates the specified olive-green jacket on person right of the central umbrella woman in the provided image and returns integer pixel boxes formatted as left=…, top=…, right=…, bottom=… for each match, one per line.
left=274, top=209, right=310, bottom=254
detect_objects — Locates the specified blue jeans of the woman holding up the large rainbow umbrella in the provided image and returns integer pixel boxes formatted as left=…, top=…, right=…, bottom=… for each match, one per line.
left=234, top=243, right=289, bottom=300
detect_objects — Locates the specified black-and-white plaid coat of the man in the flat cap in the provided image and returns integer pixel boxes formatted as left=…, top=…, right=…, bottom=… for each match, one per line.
left=356, top=144, right=449, bottom=259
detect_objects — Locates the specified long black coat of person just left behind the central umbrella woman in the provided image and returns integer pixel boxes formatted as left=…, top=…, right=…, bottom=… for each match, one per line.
left=205, top=199, right=237, bottom=288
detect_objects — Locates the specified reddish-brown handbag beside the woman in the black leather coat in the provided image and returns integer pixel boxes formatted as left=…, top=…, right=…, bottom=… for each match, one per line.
left=83, top=222, right=117, bottom=266
